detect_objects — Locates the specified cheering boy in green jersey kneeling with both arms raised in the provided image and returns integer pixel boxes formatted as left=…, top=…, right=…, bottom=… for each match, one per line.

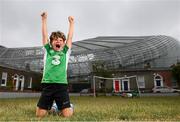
left=36, top=12, right=74, bottom=118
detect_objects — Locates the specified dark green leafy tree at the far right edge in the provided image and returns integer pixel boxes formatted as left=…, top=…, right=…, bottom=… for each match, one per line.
left=172, top=62, right=180, bottom=88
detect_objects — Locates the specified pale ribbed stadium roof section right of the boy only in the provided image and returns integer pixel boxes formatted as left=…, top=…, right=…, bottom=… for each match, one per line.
left=72, top=36, right=150, bottom=54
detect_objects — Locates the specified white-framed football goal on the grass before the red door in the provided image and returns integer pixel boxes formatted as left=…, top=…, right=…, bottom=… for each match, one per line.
left=93, top=75, right=141, bottom=97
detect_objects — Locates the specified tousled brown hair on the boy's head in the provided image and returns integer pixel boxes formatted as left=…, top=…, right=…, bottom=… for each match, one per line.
left=50, top=31, right=66, bottom=44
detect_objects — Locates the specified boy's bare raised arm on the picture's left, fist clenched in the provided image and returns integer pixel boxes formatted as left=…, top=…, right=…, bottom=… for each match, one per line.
left=41, top=12, right=48, bottom=45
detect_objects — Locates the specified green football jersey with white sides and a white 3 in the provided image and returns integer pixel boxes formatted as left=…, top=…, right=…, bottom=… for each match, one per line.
left=42, top=44, right=71, bottom=84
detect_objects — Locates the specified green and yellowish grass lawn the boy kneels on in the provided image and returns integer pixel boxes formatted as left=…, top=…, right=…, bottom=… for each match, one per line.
left=0, top=96, right=180, bottom=121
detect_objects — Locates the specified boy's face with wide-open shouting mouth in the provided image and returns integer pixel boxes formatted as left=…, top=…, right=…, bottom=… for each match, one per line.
left=51, top=37, right=65, bottom=51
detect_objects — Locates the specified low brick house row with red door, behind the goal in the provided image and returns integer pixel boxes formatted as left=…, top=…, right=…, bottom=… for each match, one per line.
left=92, top=68, right=178, bottom=92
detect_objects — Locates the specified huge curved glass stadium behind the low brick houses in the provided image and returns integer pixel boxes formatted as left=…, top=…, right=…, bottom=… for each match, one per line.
left=0, top=35, right=180, bottom=78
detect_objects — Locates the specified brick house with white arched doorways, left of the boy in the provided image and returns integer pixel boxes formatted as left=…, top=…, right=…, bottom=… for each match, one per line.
left=0, top=65, right=42, bottom=91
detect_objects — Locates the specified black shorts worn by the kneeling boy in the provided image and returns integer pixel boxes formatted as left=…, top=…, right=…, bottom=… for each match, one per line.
left=37, top=83, right=70, bottom=110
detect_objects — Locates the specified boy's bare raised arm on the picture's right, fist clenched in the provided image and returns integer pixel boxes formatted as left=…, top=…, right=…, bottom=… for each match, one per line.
left=66, top=16, right=74, bottom=48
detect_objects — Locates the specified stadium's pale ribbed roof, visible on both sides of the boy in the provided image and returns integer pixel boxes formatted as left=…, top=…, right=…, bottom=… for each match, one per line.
left=0, top=35, right=177, bottom=55
